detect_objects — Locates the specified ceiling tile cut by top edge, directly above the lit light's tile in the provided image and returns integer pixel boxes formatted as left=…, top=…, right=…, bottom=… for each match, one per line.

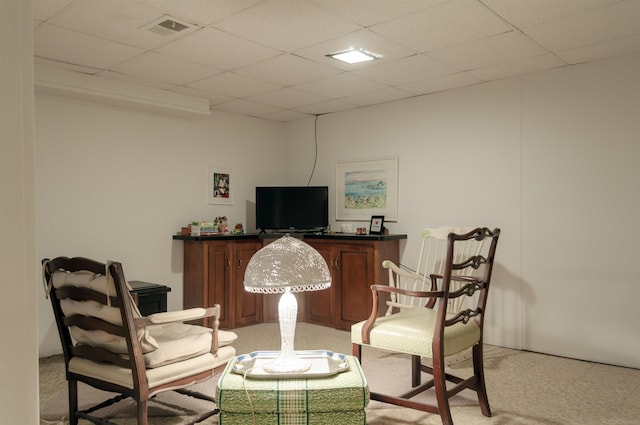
left=312, top=0, right=447, bottom=27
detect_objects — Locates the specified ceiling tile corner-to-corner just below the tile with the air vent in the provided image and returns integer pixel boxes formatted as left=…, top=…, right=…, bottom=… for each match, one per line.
left=111, top=52, right=220, bottom=84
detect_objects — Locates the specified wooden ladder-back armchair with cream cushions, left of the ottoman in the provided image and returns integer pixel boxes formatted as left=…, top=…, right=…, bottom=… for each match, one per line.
left=42, top=257, right=236, bottom=425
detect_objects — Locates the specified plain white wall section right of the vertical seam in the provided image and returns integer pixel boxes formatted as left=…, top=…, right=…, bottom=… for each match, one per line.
left=522, top=54, right=640, bottom=367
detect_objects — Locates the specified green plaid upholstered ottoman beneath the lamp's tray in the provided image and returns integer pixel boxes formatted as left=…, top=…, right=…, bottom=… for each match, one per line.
left=216, top=356, right=369, bottom=425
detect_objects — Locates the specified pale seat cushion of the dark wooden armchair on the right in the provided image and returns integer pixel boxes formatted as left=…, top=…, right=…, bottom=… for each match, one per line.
left=351, top=307, right=480, bottom=357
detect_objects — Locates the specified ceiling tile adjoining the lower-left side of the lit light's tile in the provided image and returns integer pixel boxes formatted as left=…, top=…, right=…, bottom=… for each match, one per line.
left=234, top=53, right=341, bottom=86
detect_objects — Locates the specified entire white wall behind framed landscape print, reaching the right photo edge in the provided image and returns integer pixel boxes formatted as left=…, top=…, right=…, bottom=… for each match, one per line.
left=286, top=54, right=640, bottom=367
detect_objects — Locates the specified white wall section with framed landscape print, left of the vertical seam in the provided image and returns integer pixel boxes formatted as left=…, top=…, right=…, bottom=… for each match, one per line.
left=287, top=81, right=521, bottom=347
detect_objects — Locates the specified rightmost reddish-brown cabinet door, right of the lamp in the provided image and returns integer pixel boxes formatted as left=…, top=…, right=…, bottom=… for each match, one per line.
left=334, top=243, right=375, bottom=330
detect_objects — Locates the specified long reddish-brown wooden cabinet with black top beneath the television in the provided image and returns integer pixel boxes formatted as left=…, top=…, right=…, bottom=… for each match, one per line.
left=174, top=235, right=406, bottom=330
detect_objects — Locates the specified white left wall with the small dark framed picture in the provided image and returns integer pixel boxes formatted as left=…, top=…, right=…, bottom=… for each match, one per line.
left=36, top=95, right=284, bottom=356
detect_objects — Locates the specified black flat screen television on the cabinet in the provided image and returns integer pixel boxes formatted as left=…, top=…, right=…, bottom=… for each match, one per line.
left=256, top=186, right=329, bottom=232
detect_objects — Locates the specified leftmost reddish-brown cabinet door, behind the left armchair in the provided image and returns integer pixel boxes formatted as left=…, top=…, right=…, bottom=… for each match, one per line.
left=206, top=242, right=235, bottom=329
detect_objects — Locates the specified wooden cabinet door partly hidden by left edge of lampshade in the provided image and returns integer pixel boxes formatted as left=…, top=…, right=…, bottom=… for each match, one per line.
left=233, top=241, right=263, bottom=326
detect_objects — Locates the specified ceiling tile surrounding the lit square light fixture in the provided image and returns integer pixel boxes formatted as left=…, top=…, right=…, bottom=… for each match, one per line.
left=294, top=29, right=416, bottom=71
